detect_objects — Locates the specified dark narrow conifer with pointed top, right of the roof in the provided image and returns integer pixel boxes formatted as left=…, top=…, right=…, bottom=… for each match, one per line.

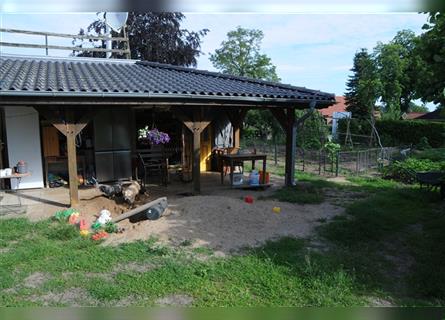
left=345, top=49, right=380, bottom=119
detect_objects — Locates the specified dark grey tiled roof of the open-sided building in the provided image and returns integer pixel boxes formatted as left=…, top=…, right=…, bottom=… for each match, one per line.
left=0, top=56, right=335, bottom=104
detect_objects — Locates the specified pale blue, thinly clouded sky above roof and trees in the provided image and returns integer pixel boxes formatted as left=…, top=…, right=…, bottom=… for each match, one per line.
left=0, top=13, right=432, bottom=108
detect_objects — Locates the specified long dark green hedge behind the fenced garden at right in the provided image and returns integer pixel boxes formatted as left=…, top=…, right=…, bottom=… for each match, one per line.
left=339, top=119, right=445, bottom=148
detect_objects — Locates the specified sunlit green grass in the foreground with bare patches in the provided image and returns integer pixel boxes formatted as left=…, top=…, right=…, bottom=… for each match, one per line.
left=0, top=219, right=365, bottom=306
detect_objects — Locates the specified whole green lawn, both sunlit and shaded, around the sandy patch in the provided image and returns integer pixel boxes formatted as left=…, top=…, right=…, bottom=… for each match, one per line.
left=0, top=175, right=445, bottom=306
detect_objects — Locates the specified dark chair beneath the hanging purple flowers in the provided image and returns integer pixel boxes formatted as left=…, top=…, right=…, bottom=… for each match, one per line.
left=138, top=146, right=168, bottom=187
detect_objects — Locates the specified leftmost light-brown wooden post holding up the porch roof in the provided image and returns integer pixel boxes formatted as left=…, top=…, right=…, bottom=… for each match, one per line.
left=66, top=111, right=79, bottom=207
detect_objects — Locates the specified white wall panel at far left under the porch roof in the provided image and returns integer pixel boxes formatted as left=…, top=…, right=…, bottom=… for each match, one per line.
left=4, top=107, right=43, bottom=189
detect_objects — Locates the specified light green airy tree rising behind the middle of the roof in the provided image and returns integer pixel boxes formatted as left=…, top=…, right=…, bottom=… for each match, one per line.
left=209, top=27, right=280, bottom=81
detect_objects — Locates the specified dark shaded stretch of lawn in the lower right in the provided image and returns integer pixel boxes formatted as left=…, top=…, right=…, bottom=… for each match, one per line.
left=319, top=185, right=445, bottom=305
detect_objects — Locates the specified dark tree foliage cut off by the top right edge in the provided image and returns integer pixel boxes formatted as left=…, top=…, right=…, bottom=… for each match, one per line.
left=418, top=12, right=445, bottom=107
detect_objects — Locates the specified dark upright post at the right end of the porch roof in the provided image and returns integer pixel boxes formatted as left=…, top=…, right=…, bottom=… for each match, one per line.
left=284, top=108, right=297, bottom=187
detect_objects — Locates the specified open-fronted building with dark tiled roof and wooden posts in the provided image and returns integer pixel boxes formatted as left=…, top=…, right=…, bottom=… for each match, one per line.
left=0, top=54, right=335, bottom=205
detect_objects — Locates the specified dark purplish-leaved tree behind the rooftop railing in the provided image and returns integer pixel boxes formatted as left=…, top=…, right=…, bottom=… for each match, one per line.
left=74, top=12, right=208, bottom=66
